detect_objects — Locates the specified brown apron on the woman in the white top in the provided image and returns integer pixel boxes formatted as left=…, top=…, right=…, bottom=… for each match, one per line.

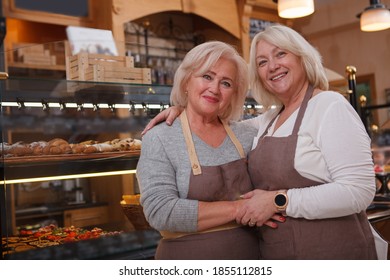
left=248, top=86, right=376, bottom=260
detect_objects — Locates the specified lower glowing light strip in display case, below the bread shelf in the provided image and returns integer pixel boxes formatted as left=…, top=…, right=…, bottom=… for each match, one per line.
left=0, top=169, right=136, bottom=185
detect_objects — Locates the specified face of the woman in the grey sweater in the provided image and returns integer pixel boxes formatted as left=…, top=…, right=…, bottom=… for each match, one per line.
left=186, top=58, right=237, bottom=118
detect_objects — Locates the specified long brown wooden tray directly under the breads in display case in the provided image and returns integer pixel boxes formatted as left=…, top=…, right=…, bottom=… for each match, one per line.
left=3, top=150, right=140, bottom=165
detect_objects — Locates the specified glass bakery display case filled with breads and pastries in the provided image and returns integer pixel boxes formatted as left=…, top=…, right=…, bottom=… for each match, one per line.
left=0, top=43, right=171, bottom=259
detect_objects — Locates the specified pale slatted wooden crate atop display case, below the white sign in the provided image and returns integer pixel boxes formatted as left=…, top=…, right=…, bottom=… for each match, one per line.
left=66, top=53, right=152, bottom=84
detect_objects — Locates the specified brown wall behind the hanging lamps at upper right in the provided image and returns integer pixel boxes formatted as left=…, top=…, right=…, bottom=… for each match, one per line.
left=293, top=0, right=390, bottom=104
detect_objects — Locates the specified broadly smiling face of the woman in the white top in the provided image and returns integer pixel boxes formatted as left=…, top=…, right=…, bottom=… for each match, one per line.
left=256, top=40, right=307, bottom=99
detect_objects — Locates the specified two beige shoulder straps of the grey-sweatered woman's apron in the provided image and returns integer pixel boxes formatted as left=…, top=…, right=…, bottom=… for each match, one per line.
left=180, top=110, right=246, bottom=175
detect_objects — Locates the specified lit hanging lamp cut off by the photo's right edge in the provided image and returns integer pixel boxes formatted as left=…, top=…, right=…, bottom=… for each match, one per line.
left=356, top=0, right=390, bottom=32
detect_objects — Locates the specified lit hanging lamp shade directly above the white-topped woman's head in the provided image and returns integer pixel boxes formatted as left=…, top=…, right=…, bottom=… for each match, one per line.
left=273, top=0, right=314, bottom=18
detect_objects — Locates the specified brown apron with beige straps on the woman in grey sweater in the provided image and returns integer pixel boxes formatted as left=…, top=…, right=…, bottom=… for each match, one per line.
left=155, top=111, right=259, bottom=260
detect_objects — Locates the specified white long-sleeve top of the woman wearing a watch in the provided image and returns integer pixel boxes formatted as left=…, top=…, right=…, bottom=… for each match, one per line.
left=245, top=91, right=376, bottom=219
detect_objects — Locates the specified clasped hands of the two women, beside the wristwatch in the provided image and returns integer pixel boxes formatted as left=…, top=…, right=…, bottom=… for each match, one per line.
left=236, top=189, right=286, bottom=228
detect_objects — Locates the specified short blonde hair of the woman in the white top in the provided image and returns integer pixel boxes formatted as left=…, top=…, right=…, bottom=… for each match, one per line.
left=249, top=24, right=329, bottom=108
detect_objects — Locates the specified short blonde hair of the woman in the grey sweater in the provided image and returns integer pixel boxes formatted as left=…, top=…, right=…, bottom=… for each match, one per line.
left=171, top=41, right=249, bottom=121
